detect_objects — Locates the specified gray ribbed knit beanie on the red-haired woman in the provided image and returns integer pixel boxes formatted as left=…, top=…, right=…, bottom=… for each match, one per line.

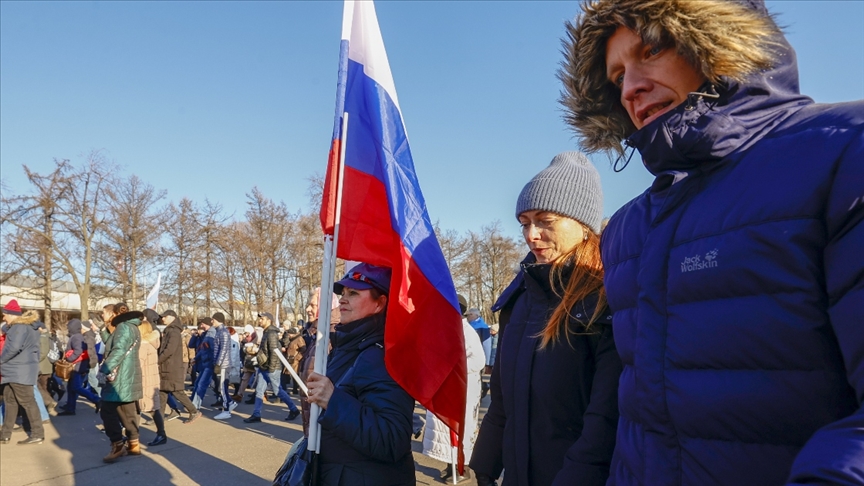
left=516, top=152, right=603, bottom=234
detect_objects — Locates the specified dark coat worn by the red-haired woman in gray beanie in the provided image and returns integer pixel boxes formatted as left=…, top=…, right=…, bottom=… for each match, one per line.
left=471, top=254, right=621, bottom=486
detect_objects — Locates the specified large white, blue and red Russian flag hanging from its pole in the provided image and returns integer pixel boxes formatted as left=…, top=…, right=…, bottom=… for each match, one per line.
left=321, top=0, right=467, bottom=463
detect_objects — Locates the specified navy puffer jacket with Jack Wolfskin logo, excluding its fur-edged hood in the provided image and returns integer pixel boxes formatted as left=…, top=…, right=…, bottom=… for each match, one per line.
left=602, top=3, right=864, bottom=486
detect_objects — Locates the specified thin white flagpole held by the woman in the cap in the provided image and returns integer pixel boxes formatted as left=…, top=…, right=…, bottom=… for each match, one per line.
left=309, top=112, right=348, bottom=454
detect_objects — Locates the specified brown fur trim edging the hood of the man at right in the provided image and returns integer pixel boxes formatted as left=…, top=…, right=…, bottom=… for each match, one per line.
left=558, top=0, right=780, bottom=153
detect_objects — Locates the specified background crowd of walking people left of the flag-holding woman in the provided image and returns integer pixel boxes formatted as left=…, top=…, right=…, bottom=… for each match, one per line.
left=0, top=299, right=314, bottom=463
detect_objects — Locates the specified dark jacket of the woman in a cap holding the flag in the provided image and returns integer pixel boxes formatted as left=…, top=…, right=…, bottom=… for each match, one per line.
left=318, top=313, right=416, bottom=486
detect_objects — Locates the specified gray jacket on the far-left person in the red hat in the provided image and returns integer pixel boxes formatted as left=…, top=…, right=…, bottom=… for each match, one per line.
left=0, top=310, right=44, bottom=385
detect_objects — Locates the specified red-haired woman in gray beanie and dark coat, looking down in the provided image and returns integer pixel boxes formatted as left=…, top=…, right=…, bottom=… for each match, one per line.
left=471, top=152, right=622, bottom=486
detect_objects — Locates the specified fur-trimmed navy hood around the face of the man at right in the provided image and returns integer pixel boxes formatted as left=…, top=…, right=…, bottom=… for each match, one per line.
left=558, top=0, right=802, bottom=159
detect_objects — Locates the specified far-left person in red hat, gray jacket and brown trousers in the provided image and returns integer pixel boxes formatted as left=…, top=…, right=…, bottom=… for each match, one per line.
left=0, top=299, right=45, bottom=445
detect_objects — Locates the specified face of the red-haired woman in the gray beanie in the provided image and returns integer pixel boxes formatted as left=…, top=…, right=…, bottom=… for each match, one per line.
left=519, top=211, right=585, bottom=263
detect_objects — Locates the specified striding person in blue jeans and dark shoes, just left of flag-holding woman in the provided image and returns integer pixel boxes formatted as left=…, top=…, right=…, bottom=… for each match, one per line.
left=243, top=312, right=300, bottom=424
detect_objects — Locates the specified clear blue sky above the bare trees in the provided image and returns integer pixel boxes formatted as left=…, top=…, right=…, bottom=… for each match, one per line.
left=0, top=1, right=864, bottom=236
